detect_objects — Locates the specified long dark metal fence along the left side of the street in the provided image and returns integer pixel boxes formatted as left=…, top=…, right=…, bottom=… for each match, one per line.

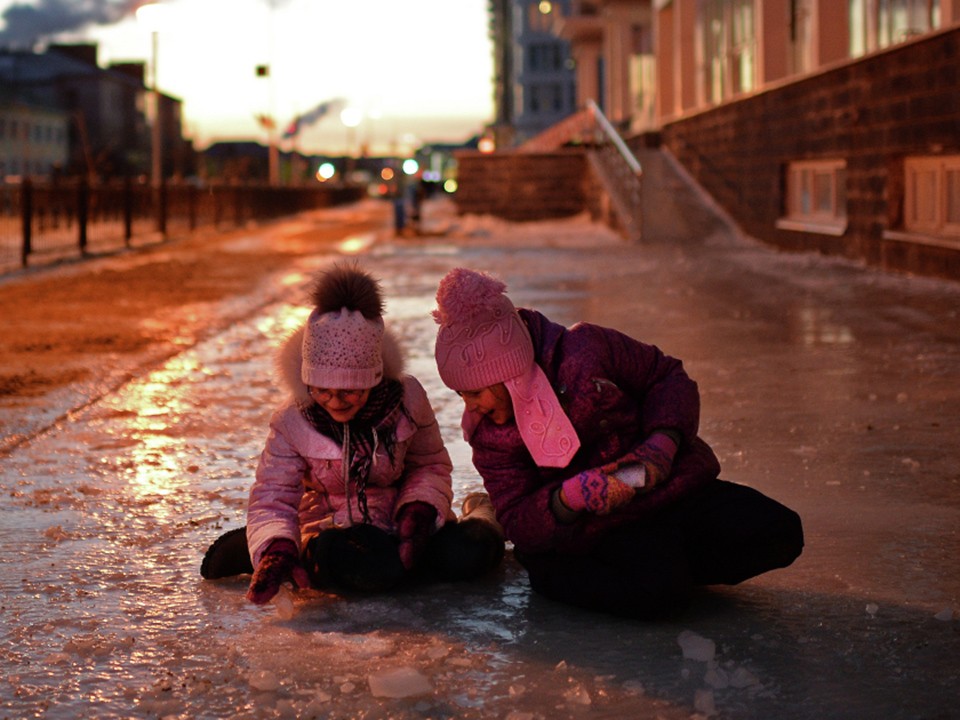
left=0, top=180, right=364, bottom=273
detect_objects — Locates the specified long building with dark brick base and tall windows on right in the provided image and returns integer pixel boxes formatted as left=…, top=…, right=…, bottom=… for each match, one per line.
left=524, top=0, right=960, bottom=278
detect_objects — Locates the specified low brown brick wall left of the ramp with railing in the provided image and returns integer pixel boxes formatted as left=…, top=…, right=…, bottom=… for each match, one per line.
left=454, top=149, right=592, bottom=222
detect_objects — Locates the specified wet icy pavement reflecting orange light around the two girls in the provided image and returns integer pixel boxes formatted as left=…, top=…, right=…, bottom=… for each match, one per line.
left=0, top=198, right=960, bottom=720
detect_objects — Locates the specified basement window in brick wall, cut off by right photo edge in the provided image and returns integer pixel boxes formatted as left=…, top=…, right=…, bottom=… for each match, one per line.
left=903, top=155, right=960, bottom=237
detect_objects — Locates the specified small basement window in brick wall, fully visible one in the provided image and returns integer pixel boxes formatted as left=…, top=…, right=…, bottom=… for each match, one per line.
left=777, top=160, right=847, bottom=235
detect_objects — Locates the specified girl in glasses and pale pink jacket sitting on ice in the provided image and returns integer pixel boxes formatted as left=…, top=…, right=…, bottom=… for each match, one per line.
left=201, top=265, right=504, bottom=604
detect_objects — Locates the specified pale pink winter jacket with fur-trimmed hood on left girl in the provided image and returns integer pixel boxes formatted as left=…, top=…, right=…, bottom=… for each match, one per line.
left=247, top=330, right=455, bottom=567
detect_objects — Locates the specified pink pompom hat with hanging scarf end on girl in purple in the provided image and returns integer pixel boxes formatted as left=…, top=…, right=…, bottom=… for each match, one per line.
left=433, top=268, right=580, bottom=467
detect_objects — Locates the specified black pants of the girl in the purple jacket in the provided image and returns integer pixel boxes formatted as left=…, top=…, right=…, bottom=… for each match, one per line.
left=514, top=480, right=803, bottom=618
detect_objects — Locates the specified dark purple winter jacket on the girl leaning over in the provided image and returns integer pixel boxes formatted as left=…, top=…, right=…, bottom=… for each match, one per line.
left=470, top=309, right=720, bottom=553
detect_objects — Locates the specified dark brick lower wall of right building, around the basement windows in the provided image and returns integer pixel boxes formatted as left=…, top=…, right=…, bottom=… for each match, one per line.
left=662, top=29, right=960, bottom=279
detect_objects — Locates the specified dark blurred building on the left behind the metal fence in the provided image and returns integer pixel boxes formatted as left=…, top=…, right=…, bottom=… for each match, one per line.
left=0, top=44, right=193, bottom=180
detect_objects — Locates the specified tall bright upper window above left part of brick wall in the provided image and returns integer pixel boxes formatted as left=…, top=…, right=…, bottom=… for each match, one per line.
left=698, top=0, right=756, bottom=104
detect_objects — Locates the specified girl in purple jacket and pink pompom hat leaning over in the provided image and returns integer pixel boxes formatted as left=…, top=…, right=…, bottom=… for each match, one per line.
left=434, top=268, right=803, bottom=618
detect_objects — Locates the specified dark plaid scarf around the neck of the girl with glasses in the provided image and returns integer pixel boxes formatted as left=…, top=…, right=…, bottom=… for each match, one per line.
left=300, top=380, right=403, bottom=523
